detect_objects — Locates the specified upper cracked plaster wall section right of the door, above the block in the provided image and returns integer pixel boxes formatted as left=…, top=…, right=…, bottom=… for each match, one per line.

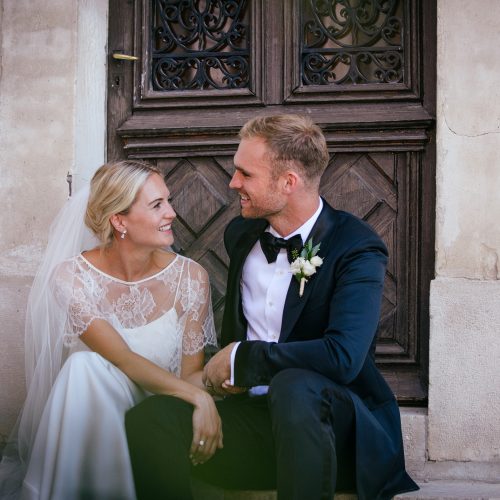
left=436, top=0, right=500, bottom=279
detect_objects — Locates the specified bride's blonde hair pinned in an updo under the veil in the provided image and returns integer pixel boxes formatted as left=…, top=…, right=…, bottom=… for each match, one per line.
left=85, top=160, right=161, bottom=246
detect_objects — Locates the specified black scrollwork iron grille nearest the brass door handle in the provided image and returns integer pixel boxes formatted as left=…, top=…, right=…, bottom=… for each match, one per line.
left=151, top=0, right=250, bottom=91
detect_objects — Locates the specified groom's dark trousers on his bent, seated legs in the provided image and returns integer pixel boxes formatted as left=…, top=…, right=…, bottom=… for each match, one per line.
left=125, top=369, right=355, bottom=500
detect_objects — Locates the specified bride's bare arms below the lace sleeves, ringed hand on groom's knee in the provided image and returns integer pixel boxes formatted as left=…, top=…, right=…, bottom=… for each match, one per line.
left=80, top=319, right=222, bottom=464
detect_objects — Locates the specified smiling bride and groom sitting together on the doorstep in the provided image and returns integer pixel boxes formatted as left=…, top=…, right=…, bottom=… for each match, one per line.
left=0, top=115, right=417, bottom=500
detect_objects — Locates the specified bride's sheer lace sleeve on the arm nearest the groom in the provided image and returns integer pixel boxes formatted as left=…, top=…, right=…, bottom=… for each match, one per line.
left=180, top=260, right=217, bottom=355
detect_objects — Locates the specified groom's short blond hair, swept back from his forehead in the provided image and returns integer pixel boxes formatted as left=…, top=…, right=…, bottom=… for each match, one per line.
left=239, top=115, right=330, bottom=188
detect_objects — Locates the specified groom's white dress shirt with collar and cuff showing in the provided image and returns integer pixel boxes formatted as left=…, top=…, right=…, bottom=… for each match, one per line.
left=231, top=198, right=323, bottom=394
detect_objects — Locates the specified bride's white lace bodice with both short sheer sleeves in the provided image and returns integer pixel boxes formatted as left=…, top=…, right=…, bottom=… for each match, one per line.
left=54, top=255, right=216, bottom=376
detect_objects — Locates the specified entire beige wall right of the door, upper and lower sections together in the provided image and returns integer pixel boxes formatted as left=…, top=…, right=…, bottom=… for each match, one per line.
left=428, top=0, right=500, bottom=462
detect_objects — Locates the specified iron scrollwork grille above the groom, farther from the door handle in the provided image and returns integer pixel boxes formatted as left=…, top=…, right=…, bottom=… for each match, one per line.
left=301, top=0, right=404, bottom=85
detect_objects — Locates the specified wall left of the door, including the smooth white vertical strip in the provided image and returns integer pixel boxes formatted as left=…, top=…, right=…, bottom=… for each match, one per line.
left=0, top=0, right=107, bottom=448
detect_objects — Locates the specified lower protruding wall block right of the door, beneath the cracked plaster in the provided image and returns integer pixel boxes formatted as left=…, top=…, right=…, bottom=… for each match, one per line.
left=428, top=278, right=500, bottom=460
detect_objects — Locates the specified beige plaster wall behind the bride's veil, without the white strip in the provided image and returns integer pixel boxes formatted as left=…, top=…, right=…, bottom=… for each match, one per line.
left=0, top=0, right=77, bottom=446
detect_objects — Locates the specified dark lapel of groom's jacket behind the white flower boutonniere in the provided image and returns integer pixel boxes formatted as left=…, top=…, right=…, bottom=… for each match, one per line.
left=279, top=200, right=336, bottom=342
